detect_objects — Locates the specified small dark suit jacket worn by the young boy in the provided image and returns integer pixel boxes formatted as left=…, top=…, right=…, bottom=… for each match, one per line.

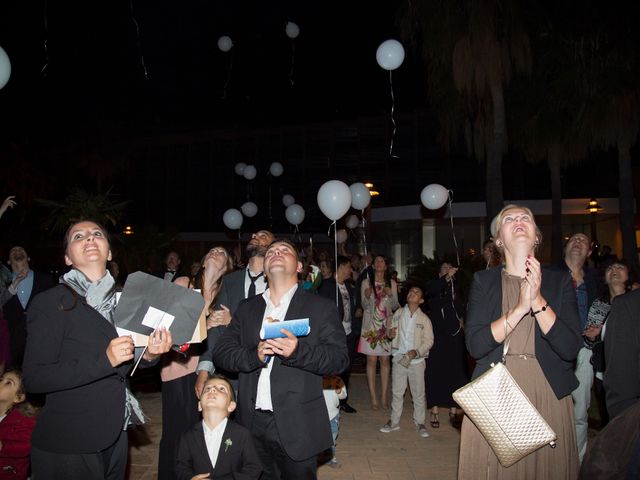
left=175, top=420, right=262, bottom=480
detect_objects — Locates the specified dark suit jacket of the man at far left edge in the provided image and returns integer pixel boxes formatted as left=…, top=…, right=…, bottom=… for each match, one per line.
left=2, top=271, right=53, bottom=365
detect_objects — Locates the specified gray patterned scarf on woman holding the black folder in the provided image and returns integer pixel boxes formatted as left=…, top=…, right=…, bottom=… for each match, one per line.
left=60, top=268, right=145, bottom=430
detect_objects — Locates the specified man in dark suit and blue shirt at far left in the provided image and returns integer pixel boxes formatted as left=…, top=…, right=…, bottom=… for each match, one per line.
left=0, top=246, right=53, bottom=367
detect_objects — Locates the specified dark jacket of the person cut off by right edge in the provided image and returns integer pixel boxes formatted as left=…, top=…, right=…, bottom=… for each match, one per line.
left=603, top=290, right=640, bottom=418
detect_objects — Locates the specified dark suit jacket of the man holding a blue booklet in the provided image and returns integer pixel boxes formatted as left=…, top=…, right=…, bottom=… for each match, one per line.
left=213, top=286, right=349, bottom=461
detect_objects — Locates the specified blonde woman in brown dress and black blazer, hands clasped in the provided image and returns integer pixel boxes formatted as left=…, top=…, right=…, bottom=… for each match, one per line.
left=458, top=205, right=582, bottom=480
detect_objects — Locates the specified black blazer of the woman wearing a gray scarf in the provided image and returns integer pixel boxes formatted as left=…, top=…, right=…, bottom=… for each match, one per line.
left=23, top=285, right=131, bottom=453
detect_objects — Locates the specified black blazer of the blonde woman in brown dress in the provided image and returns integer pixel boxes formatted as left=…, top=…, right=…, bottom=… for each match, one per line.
left=465, top=266, right=582, bottom=398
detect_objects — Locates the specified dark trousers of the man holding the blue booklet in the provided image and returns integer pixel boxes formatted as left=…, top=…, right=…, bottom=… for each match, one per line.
left=251, top=410, right=317, bottom=480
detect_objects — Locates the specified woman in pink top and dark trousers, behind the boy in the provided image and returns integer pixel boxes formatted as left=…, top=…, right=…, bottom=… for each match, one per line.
left=158, top=246, right=232, bottom=480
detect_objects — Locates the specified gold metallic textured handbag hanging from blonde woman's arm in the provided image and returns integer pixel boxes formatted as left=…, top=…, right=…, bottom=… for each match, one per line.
left=453, top=321, right=556, bottom=467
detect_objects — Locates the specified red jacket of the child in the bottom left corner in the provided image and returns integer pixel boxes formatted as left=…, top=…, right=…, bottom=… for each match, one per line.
left=0, top=409, right=36, bottom=480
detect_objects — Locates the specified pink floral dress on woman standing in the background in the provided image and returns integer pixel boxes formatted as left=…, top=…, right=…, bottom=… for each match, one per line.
left=358, top=278, right=400, bottom=356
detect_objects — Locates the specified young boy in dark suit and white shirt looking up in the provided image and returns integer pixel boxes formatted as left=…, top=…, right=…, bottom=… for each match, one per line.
left=175, top=375, right=262, bottom=480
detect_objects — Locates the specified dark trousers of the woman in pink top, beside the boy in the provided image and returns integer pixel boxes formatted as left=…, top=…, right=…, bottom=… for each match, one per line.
left=158, top=373, right=200, bottom=480
